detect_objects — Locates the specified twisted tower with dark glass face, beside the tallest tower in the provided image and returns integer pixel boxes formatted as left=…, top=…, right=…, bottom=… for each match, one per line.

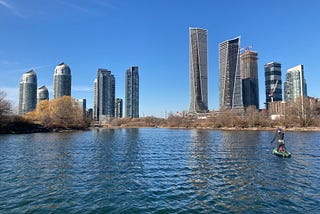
left=219, top=37, right=243, bottom=109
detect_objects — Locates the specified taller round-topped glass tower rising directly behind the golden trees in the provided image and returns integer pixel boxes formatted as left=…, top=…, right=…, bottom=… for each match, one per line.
left=53, top=62, right=71, bottom=99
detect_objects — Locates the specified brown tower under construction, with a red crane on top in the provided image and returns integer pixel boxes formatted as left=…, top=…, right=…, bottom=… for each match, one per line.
left=240, top=50, right=259, bottom=109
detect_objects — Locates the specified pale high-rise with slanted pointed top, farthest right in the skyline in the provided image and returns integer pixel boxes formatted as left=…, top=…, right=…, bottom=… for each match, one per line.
left=284, top=65, right=307, bottom=102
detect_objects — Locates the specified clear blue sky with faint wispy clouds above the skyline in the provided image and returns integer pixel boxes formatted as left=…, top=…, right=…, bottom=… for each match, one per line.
left=0, top=0, right=320, bottom=117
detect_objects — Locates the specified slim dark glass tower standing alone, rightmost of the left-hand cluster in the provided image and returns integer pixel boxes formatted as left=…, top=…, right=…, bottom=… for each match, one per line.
left=126, top=66, right=139, bottom=118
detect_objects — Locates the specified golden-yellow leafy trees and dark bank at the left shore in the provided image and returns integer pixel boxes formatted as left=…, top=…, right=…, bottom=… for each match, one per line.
left=0, top=90, right=91, bottom=133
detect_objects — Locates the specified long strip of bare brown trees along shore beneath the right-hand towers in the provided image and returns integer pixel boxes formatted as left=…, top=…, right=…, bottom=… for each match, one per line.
left=108, top=98, right=320, bottom=129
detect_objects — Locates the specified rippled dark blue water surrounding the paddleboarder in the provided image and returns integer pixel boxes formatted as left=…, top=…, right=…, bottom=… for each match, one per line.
left=0, top=129, right=320, bottom=213
